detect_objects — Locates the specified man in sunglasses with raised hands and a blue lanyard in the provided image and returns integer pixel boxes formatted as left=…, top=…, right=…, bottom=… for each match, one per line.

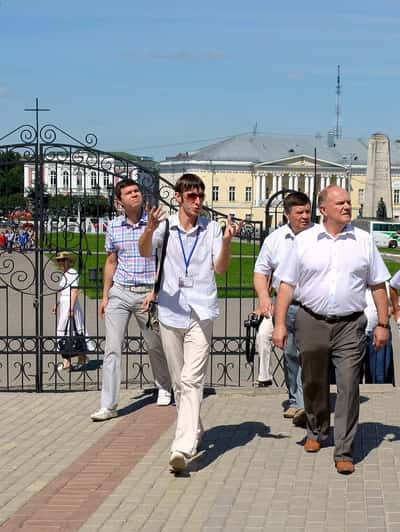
left=139, top=174, right=243, bottom=473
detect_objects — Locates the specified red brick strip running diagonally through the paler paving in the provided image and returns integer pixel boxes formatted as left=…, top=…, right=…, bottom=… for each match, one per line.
left=0, top=404, right=175, bottom=532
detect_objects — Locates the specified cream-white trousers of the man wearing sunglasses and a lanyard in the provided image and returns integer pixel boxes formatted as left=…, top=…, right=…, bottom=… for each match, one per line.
left=160, top=315, right=213, bottom=456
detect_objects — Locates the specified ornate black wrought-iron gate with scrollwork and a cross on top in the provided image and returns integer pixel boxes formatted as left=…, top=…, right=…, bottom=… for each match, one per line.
left=0, top=105, right=283, bottom=392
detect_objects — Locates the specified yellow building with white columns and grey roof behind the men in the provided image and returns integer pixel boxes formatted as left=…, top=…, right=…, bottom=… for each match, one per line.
left=160, top=134, right=400, bottom=227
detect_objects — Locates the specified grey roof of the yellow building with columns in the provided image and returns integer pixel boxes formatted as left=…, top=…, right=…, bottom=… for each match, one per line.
left=161, top=134, right=400, bottom=165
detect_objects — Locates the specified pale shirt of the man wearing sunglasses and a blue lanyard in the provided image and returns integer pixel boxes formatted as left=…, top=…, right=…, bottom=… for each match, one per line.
left=153, top=214, right=222, bottom=329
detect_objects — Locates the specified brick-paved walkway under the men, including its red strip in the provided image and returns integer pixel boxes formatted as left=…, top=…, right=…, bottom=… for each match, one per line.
left=0, top=386, right=400, bottom=532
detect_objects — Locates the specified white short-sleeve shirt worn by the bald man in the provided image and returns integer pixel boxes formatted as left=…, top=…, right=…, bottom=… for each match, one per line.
left=277, top=224, right=390, bottom=316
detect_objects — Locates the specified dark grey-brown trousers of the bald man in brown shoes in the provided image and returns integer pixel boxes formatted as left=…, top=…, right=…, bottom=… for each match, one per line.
left=296, top=308, right=367, bottom=462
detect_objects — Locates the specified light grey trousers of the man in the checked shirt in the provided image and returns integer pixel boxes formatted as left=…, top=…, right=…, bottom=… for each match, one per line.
left=101, top=285, right=171, bottom=409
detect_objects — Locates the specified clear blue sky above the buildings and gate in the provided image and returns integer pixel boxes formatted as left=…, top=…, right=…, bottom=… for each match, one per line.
left=0, top=0, right=400, bottom=159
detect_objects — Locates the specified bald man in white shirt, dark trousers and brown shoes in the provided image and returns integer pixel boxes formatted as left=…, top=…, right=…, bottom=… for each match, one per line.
left=273, top=185, right=390, bottom=474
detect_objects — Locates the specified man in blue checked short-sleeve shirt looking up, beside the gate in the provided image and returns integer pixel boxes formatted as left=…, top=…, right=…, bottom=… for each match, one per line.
left=91, top=179, right=171, bottom=421
